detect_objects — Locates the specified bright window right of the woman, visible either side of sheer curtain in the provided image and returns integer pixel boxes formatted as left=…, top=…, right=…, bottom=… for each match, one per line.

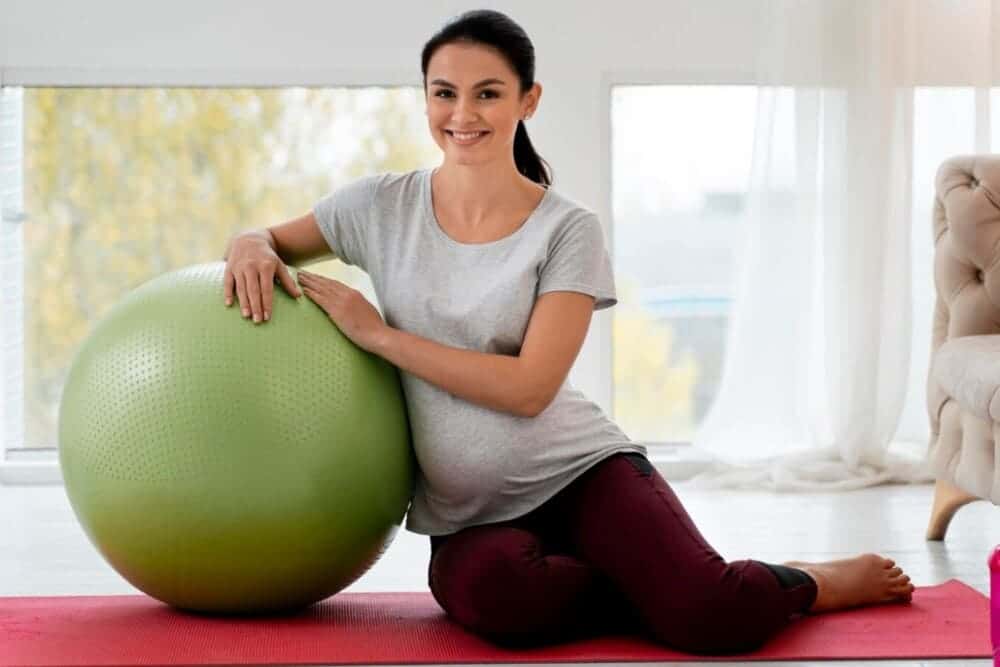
left=611, top=85, right=1000, bottom=444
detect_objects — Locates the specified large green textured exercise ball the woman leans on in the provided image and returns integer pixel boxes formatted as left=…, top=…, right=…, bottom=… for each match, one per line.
left=59, top=262, right=416, bottom=614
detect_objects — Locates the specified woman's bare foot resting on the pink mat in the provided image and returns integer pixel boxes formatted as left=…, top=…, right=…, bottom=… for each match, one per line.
left=783, top=554, right=914, bottom=612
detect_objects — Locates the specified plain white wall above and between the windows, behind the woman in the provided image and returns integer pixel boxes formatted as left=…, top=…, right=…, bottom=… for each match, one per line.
left=0, top=0, right=759, bottom=414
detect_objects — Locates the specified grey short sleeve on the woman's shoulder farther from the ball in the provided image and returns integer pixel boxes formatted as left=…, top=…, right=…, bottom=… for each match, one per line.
left=538, top=213, right=618, bottom=310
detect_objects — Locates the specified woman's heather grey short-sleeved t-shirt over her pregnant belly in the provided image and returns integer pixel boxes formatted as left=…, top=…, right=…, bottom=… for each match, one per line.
left=313, top=169, right=647, bottom=535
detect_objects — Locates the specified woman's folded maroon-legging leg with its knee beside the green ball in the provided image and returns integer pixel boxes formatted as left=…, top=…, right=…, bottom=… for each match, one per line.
left=428, top=505, right=636, bottom=646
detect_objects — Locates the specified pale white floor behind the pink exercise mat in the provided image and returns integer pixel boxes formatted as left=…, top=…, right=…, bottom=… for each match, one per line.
left=0, top=474, right=1000, bottom=667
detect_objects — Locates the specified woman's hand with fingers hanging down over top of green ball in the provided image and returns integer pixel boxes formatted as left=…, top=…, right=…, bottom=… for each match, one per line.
left=222, top=230, right=302, bottom=324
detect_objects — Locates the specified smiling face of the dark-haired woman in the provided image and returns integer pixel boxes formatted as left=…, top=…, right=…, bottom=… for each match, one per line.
left=426, top=43, right=542, bottom=164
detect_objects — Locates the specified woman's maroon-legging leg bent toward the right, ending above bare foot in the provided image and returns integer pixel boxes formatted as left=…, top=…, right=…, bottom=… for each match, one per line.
left=554, top=453, right=817, bottom=654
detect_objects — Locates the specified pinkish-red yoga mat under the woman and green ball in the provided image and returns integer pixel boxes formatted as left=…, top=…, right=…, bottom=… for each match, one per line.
left=0, top=579, right=991, bottom=667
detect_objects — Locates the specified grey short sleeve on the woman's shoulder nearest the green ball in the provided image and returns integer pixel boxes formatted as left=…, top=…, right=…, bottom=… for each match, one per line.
left=313, top=174, right=379, bottom=272
